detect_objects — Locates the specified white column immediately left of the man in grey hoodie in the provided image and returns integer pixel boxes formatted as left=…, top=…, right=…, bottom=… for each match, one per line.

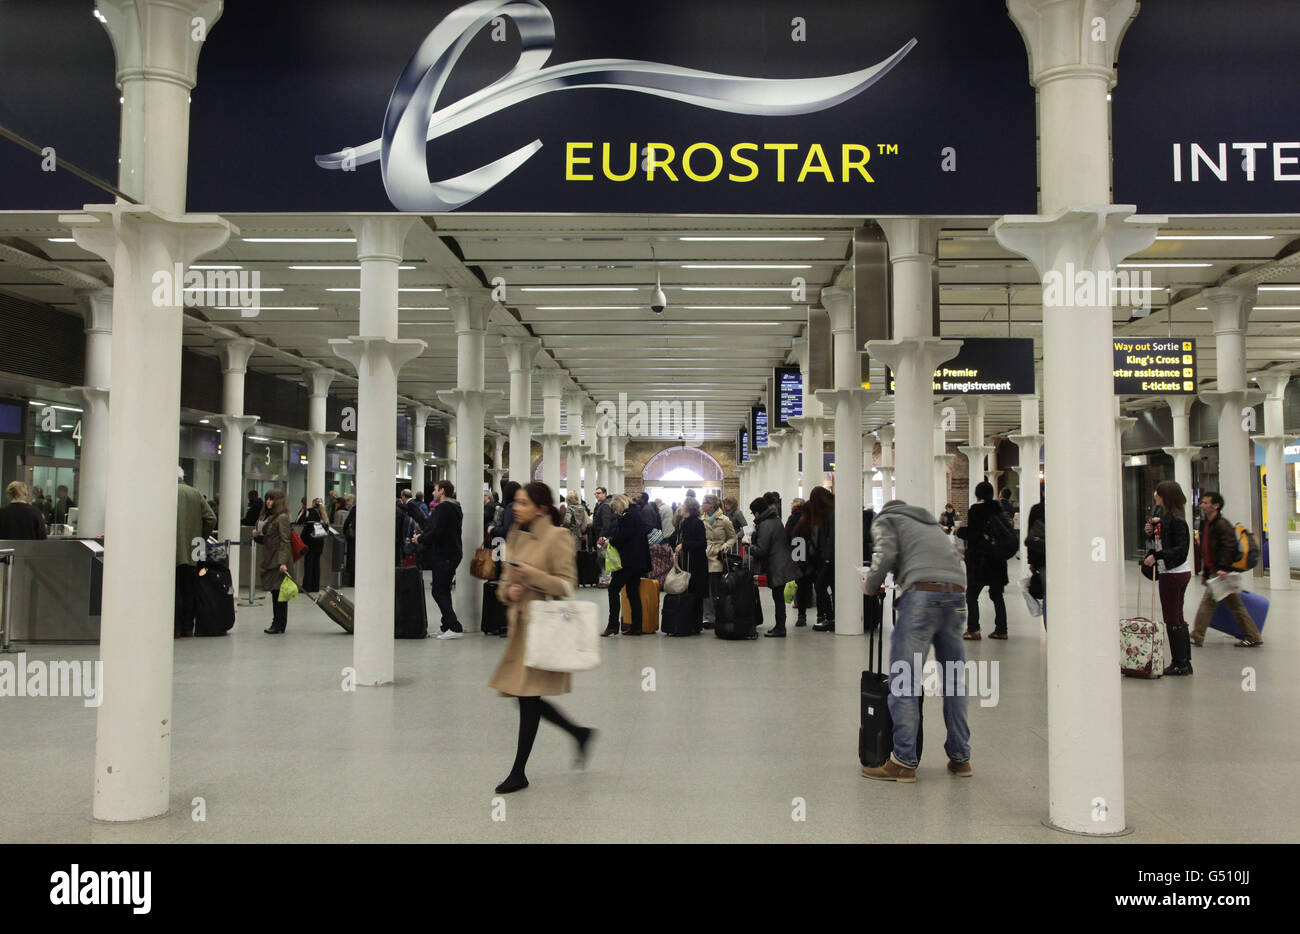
left=818, top=287, right=880, bottom=636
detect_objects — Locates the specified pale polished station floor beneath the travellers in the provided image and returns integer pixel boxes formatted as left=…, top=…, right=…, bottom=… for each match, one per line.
left=0, top=567, right=1300, bottom=843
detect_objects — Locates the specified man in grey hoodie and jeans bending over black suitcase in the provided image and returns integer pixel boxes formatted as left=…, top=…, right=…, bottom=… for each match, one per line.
left=862, top=500, right=971, bottom=782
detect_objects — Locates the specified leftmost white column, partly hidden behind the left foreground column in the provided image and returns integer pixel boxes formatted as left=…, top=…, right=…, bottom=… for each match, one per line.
left=77, top=289, right=114, bottom=539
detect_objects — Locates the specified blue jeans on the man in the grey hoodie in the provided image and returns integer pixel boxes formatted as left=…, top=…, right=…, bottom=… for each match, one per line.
left=889, top=591, right=971, bottom=769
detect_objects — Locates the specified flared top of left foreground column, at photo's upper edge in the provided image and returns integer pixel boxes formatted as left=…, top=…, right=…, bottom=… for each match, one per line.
left=95, top=0, right=224, bottom=90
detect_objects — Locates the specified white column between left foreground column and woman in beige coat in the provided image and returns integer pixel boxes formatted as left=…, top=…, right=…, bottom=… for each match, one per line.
left=330, top=216, right=425, bottom=686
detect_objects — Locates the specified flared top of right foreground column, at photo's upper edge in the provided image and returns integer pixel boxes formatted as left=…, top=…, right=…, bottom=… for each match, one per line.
left=1006, top=0, right=1138, bottom=87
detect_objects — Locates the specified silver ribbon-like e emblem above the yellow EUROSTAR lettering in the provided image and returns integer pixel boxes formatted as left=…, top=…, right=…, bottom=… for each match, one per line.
left=316, top=0, right=917, bottom=212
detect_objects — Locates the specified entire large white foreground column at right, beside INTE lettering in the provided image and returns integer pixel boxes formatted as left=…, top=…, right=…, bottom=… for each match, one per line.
left=992, top=0, right=1164, bottom=835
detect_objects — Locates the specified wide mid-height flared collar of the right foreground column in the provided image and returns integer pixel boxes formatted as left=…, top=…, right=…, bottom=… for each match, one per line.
left=989, top=204, right=1169, bottom=279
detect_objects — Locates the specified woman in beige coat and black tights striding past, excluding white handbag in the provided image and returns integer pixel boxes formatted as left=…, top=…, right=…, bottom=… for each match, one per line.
left=489, top=483, right=595, bottom=795
